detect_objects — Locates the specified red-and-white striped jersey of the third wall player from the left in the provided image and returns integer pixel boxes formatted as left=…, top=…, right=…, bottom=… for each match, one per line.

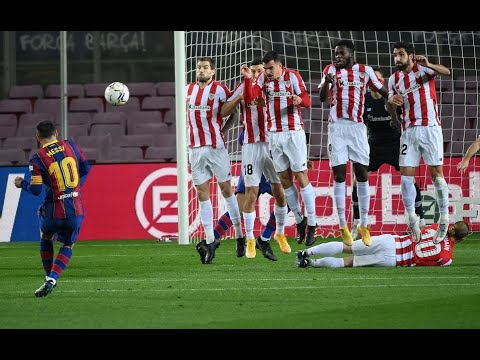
left=253, top=68, right=309, bottom=131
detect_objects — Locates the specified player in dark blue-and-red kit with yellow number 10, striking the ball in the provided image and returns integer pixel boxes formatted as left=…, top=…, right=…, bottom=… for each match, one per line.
left=14, top=120, right=90, bottom=297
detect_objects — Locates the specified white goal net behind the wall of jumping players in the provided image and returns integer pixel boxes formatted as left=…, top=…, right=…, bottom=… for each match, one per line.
left=179, top=31, right=480, bottom=242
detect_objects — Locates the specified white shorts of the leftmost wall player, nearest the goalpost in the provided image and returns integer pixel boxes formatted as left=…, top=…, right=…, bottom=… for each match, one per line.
left=188, top=145, right=232, bottom=185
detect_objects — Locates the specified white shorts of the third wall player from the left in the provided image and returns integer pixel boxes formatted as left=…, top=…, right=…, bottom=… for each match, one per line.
left=270, top=129, right=307, bottom=173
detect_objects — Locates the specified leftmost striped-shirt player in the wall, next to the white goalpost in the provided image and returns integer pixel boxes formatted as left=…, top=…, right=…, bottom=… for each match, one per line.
left=186, top=57, right=243, bottom=264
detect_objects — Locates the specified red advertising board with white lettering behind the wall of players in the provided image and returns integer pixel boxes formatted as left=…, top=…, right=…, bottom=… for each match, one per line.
left=79, top=158, right=480, bottom=240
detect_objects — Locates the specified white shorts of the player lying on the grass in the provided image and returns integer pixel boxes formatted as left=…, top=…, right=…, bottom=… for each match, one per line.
left=352, top=234, right=397, bottom=267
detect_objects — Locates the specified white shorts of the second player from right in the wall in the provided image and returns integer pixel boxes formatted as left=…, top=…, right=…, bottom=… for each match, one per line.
left=328, top=118, right=370, bottom=167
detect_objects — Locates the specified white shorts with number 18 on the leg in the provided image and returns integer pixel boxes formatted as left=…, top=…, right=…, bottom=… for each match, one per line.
left=242, top=143, right=268, bottom=187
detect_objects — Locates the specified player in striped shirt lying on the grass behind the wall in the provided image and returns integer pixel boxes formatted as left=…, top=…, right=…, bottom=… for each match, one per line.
left=296, top=221, right=471, bottom=267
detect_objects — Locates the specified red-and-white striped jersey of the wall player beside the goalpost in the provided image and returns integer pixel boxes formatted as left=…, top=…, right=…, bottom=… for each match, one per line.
left=186, top=81, right=230, bottom=149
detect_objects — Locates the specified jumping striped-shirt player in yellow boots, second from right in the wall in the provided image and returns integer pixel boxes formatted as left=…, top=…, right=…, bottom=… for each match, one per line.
left=319, top=40, right=395, bottom=245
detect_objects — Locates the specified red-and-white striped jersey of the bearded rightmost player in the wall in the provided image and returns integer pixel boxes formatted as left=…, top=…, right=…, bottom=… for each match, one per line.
left=388, top=63, right=440, bottom=130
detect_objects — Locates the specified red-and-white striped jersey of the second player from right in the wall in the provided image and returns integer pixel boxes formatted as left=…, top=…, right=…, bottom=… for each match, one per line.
left=319, top=63, right=383, bottom=122
